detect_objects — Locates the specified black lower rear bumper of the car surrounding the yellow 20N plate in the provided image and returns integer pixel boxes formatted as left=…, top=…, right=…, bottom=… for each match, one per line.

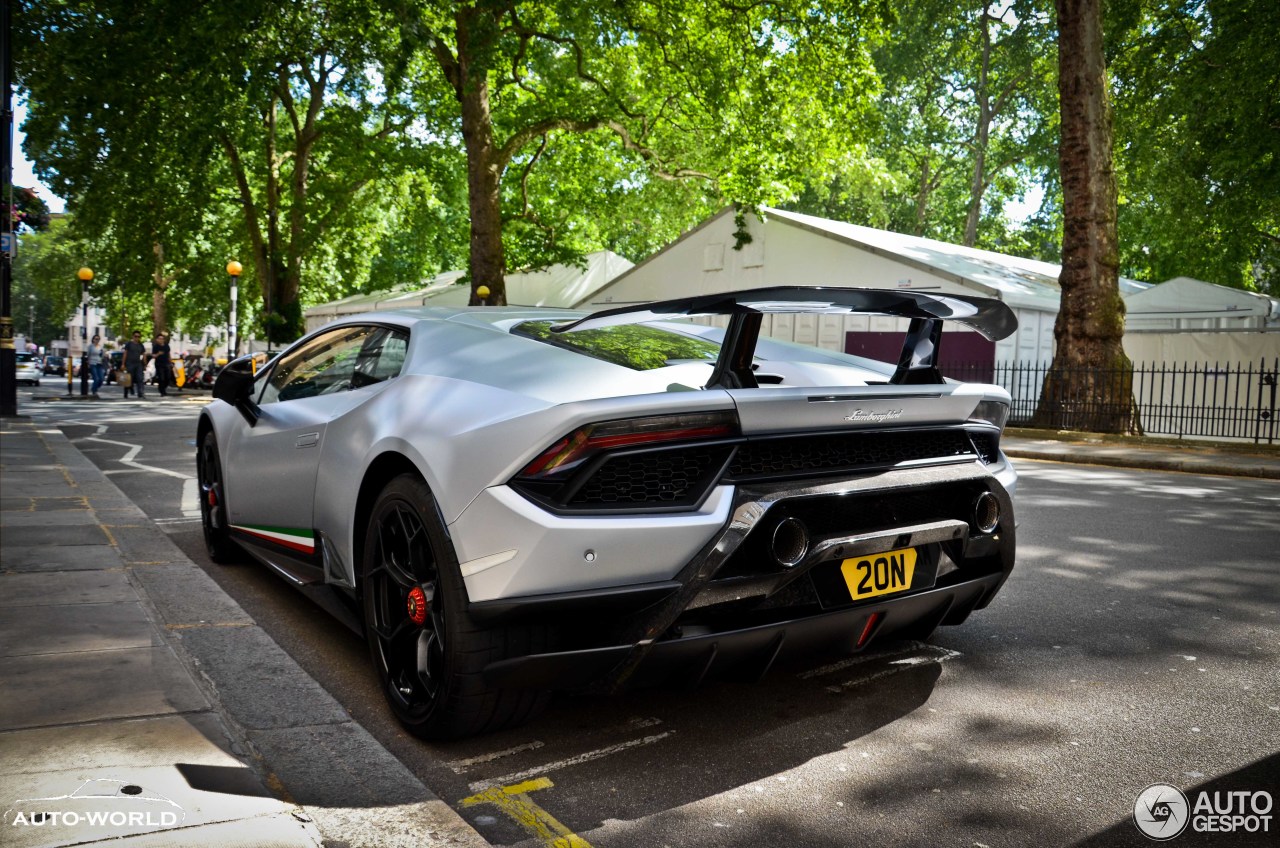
left=470, top=462, right=1015, bottom=690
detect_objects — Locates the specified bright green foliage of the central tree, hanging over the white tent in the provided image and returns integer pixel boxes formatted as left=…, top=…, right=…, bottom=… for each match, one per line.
left=398, top=0, right=876, bottom=295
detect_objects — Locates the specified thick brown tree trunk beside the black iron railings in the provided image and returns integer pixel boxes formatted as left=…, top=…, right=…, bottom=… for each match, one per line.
left=1036, top=0, right=1134, bottom=433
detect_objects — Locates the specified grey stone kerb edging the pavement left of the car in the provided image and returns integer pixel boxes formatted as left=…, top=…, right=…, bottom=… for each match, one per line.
left=38, top=428, right=490, bottom=848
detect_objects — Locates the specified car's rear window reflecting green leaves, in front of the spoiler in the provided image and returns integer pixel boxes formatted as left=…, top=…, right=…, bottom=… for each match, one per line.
left=511, top=322, right=719, bottom=371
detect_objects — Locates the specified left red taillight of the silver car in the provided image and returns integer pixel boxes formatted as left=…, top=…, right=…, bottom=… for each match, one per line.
left=520, top=411, right=739, bottom=478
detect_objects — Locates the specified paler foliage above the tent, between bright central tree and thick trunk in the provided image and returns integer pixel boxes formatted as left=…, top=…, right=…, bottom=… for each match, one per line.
left=790, top=0, right=1057, bottom=256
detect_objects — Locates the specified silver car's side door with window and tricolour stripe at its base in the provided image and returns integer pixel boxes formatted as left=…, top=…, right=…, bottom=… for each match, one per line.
left=225, top=324, right=385, bottom=582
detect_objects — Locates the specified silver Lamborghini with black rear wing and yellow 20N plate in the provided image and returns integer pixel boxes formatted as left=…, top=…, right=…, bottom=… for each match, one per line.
left=197, top=287, right=1016, bottom=738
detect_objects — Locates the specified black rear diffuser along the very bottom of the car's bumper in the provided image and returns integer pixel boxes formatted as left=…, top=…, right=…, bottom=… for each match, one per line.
left=484, top=574, right=1005, bottom=690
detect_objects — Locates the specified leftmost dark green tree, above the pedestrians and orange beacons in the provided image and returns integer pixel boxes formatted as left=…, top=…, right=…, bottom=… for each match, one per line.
left=18, top=1, right=230, bottom=332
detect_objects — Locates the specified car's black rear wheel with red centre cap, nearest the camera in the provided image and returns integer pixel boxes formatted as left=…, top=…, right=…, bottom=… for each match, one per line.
left=361, top=474, right=549, bottom=739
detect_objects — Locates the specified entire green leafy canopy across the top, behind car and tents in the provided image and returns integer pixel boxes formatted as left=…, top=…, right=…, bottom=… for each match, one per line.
left=13, top=0, right=1280, bottom=341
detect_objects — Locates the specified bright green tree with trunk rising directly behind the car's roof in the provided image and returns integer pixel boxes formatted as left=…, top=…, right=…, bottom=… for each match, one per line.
left=399, top=0, right=873, bottom=304
